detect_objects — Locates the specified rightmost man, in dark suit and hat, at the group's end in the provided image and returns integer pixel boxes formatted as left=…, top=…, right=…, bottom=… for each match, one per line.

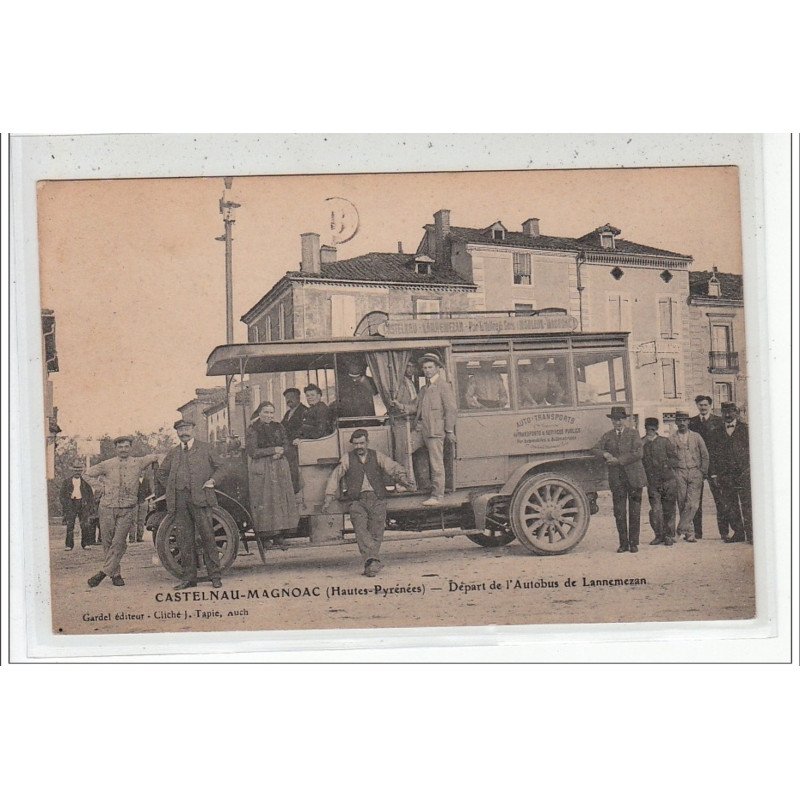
left=709, top=403, right=753, bottom=544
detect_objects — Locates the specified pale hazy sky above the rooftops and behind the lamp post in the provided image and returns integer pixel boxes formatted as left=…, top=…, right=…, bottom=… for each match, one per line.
left=38, top=167, right=742, bottom=437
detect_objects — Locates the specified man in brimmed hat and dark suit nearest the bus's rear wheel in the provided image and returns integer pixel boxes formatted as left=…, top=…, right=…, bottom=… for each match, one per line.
left=592, top=406, right=647, bottom=553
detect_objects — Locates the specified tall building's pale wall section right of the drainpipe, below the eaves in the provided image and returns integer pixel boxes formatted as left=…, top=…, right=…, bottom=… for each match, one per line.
left=581, top=264, right=694, bottom=428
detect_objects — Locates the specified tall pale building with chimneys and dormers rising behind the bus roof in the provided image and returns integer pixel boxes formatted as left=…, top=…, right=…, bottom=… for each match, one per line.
left=417, top=210, right=695, bottom=427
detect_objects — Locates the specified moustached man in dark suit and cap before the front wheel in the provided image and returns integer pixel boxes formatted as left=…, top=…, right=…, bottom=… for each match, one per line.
left=158, top=419, right=223, bottom=589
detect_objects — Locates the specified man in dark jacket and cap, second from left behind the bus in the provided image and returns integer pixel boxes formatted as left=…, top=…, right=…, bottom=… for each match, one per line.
left=642, top=417, right=678, bottom=547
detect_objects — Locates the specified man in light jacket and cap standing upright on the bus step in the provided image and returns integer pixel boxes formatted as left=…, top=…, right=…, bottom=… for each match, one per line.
left=414, top=353, right=457, bottom=506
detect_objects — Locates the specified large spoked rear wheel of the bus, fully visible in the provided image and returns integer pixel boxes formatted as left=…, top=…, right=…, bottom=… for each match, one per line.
left=510, top=472, right=589, bottom=556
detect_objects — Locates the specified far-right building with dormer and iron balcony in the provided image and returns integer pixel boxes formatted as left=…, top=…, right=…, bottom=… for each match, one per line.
left=688, top=267, right=747, bottom=415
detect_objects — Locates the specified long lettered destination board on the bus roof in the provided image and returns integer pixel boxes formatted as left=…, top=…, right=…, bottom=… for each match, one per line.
left=380, top=314, right=578, bottom=336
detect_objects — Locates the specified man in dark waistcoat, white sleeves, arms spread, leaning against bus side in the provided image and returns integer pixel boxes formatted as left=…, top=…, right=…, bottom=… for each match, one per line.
left=322, top=428, right=414, bottom=578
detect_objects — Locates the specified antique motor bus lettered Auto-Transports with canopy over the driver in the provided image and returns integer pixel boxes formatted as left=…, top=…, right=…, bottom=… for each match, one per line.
left=148, top=314, right=632, bottom=575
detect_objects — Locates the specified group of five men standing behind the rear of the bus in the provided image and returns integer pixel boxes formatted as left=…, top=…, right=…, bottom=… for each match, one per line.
left=593, top=395, right=753, bottom=553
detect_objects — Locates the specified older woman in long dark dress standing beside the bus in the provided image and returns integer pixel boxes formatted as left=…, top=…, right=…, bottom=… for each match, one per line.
left=245, top=401, right=300, bottom=548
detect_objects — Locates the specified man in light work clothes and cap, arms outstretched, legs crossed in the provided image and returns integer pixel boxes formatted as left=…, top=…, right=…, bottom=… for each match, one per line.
left=83, top=436, right=158, bottom=588
